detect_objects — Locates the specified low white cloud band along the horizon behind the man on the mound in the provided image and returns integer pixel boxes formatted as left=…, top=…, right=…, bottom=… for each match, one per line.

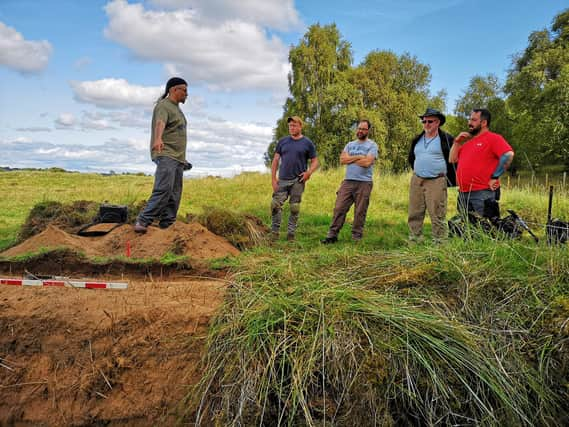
left=0, top=116, right=272, bottom=177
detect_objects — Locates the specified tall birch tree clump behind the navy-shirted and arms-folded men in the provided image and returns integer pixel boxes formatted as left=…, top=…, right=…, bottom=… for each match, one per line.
left=265, top=25, right=440, bottom=171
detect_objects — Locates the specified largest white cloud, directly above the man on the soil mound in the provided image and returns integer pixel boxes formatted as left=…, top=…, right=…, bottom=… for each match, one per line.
left=105, top=0, right=289, bottom=92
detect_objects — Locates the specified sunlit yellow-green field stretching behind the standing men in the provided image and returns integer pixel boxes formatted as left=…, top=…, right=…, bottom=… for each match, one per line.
left=0, top=170, right=569, bottom=249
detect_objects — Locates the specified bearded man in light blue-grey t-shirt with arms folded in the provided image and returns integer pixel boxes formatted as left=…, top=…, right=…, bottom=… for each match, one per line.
left=321, top=120, right=377, bottom=244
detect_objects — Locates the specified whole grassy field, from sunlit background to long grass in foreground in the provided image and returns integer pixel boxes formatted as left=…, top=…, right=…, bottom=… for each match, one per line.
left=0, top=171, right=569, bottom=425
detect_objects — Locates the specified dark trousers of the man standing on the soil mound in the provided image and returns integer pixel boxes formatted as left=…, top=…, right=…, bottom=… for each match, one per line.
left=138, top=157, right=184, bottom=227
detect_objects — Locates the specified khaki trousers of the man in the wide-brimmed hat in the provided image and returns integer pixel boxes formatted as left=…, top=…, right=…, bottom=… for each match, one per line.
left=407, top=174, right=448, bottom=239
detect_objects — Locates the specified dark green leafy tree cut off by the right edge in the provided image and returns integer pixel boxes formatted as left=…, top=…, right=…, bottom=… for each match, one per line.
left=505, top=9, right=569, bottom=170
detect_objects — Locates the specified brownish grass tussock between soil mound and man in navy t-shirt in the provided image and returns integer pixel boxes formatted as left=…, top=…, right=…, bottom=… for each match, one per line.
left=191, top=206, right=269, bottom=250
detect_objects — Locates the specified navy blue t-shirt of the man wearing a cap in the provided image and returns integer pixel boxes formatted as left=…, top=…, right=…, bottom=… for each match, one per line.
left=275, top=136, right=316, bottom=181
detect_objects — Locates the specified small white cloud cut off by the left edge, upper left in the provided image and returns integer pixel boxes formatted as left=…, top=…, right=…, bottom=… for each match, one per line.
left=0, top=22, right=52, bottom=73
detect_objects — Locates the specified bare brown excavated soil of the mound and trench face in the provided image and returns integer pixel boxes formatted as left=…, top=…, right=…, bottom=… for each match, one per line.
left=0, top=222, right=239, bottom=426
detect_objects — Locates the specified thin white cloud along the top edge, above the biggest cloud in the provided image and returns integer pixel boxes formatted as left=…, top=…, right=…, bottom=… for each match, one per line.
left=152, top=0, right=302, bottom=30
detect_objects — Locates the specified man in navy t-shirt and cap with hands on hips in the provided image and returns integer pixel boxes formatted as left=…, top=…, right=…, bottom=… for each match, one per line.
left=271, top=116, right=318, bottom=240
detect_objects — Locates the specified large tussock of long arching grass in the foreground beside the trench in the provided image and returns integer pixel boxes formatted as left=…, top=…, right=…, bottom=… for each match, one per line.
left=189, top=247, right=557, bottom=425
